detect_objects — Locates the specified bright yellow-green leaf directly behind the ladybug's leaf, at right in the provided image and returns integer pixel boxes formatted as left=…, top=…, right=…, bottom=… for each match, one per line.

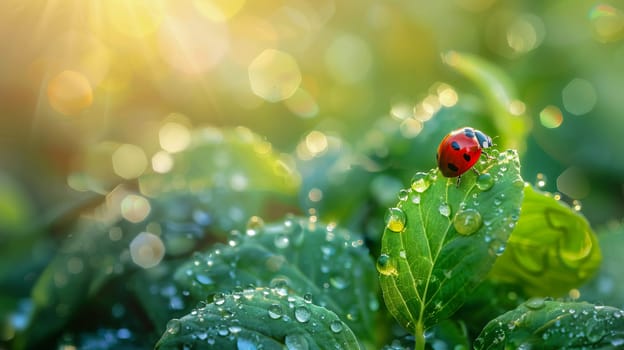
left=491, top=185, right=602, bottom=296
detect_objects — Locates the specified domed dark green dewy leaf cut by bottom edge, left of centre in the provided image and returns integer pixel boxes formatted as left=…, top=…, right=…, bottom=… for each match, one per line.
left=156, top=288, right=360, bottom=350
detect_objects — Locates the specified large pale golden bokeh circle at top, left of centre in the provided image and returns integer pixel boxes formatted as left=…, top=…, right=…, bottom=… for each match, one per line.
left=248, top=49, right=301, bottom=102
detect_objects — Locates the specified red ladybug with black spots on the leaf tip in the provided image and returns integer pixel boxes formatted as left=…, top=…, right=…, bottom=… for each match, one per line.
left=436, top=127, right=492, bottom=186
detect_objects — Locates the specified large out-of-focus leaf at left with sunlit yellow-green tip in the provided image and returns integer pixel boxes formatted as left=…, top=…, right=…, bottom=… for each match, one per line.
left=15, top=128, right=300, bottom=348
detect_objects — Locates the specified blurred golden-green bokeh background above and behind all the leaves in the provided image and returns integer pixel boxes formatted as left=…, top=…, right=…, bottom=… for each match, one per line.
left=0, top=0, right=624, bottom=348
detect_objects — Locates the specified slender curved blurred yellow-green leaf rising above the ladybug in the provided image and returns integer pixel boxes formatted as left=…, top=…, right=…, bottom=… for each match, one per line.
left=443, top=51, right=530, bottom=152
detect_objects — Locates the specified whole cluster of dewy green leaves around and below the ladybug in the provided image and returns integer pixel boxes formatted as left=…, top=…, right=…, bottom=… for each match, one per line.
left=0, top=53, right=624, bottom=349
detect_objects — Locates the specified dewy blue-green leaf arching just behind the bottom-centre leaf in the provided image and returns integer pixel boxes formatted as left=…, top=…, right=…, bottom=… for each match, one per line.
left=174, top=216, right=379, bottom=344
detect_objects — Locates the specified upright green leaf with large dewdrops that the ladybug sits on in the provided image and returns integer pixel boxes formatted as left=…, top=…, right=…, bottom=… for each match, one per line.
left=377, top=150, right=523, bottom=336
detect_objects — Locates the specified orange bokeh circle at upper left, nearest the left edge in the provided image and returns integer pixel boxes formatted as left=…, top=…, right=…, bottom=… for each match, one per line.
left=47, top=70, right=93, bottom=116
